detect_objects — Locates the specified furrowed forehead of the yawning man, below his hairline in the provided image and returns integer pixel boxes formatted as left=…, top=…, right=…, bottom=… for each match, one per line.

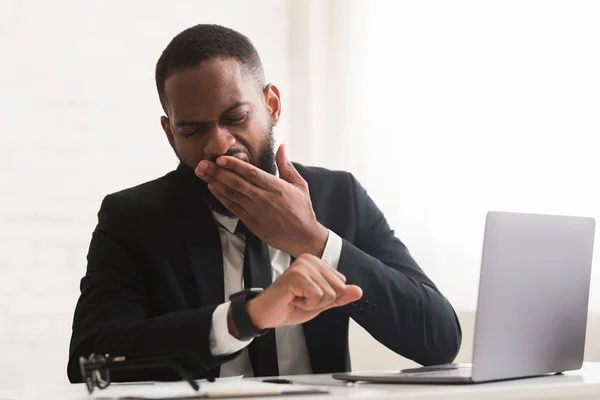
left=165, top=58, right=256, bottom=119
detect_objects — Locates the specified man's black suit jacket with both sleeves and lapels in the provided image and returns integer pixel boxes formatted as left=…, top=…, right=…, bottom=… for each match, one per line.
left=67, top=164, right=461, bottom=382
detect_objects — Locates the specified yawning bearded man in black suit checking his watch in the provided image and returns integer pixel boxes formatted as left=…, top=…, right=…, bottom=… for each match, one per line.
left=68, top=25, right=461, bottom=382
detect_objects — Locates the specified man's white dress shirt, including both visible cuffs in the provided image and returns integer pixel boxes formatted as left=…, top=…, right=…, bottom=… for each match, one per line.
left=210, top=212, right=342, bottom=377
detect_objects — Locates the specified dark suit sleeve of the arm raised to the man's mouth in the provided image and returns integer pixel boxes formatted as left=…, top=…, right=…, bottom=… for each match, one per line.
left=339, top=175, right=462, bottom=365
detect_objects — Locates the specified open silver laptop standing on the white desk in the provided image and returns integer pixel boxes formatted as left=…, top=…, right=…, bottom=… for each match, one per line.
left=333, top=212, right=595, bottom=383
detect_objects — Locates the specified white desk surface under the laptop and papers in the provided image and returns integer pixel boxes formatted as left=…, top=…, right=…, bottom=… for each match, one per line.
left=0, top=363, right=600, bottom=400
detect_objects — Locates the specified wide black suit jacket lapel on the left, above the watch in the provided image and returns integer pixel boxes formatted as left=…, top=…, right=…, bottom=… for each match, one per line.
left=173, top=165, right=225, bottom=305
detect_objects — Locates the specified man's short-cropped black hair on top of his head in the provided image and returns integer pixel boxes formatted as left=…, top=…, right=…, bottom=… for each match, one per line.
left=156, top=24, right=265, bottom=112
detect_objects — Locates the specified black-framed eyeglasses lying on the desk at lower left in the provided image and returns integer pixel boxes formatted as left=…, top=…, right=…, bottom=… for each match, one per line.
left=79, top=351, right=215, bottom=394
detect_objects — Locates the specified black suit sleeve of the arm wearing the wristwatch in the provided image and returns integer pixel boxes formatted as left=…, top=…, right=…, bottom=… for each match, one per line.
left=67, top=194, right=239, bottom=382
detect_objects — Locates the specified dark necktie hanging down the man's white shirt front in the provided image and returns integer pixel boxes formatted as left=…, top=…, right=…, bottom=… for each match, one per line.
left=236, top=221, right=279, bottom=376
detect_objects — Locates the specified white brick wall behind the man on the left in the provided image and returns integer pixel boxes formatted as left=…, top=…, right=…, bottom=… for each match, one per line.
left=0, top=0, right=289, bottom=388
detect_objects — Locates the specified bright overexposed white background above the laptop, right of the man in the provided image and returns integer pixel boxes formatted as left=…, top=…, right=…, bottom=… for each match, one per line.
left=344, top=0, right=600, bottom=311
